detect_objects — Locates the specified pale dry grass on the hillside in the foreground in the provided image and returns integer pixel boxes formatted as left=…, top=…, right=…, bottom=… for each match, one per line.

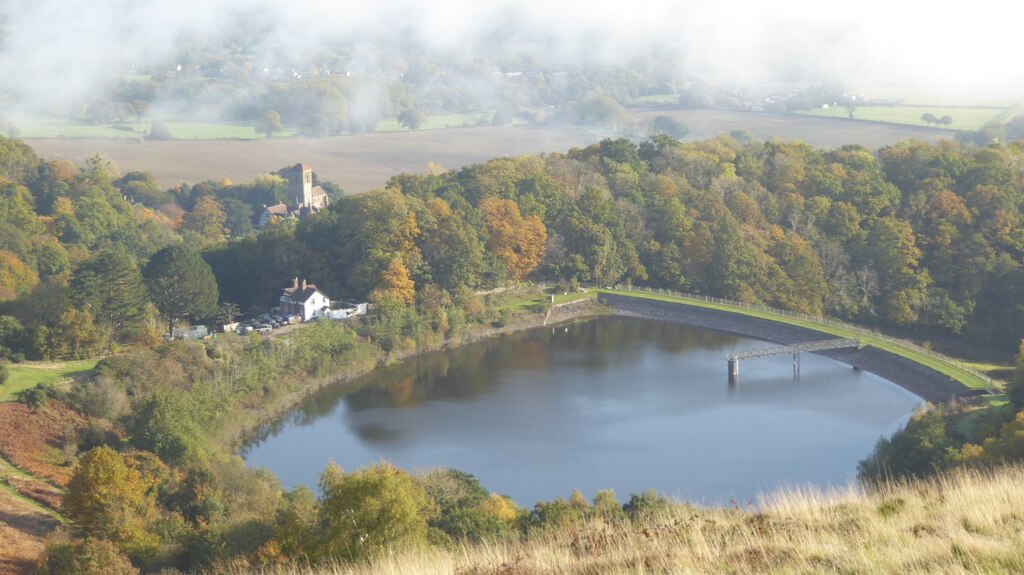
left=218, top=468, right=1024, bottom=575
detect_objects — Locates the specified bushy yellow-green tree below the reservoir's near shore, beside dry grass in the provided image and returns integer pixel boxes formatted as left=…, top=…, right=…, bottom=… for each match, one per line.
left=319, top=462, right=427, bottom=560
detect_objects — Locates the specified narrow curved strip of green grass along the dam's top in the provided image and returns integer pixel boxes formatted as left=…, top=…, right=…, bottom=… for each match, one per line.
left=599, top=290, right=993, bottom=390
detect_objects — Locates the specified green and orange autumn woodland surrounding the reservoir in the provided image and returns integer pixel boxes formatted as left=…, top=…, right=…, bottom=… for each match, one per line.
left=6, top=136, right=1024, bottom=573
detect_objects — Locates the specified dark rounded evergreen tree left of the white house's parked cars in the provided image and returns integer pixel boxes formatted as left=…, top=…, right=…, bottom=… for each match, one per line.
left=142, top=246, right=219, bottom=335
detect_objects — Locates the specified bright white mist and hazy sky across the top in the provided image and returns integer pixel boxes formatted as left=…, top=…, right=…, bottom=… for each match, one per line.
left=0, top=0, right=1024, bottom=109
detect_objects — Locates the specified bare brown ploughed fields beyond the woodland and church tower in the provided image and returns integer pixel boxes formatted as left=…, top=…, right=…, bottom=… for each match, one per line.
left=25, top=113, right=952, bottom=193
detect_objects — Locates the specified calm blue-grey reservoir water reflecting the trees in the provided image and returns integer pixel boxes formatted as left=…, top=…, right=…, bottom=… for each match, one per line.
left=243, top=317, right=922, bottom=507
